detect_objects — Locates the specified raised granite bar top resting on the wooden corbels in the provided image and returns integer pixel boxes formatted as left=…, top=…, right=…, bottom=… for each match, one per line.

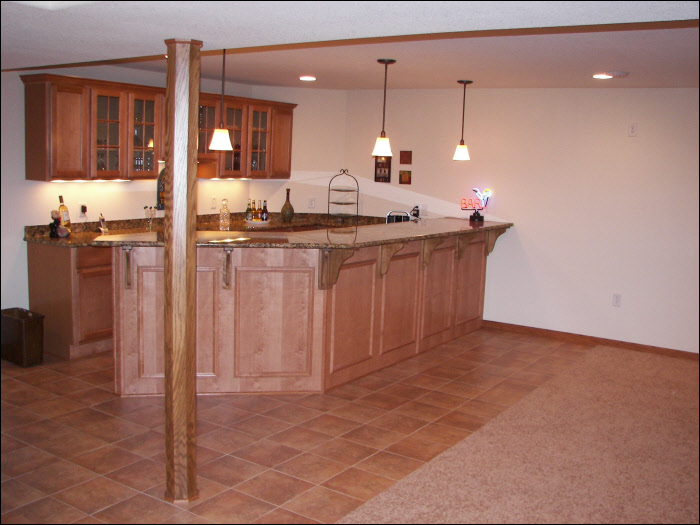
left=91, top=218, right=513, bottom=249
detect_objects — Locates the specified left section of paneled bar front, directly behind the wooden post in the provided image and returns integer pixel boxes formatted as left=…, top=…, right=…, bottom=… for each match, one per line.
left=113, top=247, right=323, bottom=395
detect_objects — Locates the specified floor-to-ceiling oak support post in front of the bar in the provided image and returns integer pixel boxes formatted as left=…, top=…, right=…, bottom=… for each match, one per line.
left=164, top=39, right=202, bottom=502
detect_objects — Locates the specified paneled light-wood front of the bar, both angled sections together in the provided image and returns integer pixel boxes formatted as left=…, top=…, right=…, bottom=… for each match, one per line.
left=113, top=233, right=487, bottom=395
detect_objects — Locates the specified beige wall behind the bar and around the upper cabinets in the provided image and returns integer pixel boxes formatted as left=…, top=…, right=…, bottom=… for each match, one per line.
left=2, top=64, right=699, bottom=352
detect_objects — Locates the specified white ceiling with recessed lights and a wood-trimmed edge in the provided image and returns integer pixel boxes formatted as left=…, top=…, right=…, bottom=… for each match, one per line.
left=1, top=1, right=700, bottom=89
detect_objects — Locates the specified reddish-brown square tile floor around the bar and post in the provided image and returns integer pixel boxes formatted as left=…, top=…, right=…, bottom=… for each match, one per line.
left=2, top=329, right=590, bottom=523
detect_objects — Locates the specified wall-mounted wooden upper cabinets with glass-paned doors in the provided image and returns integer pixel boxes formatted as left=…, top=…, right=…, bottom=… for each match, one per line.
left=21, top=74, right=296, bottom=181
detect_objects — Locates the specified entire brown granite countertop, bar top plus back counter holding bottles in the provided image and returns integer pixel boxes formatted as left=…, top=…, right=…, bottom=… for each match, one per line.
left=24, top=214, right=513, bottom=249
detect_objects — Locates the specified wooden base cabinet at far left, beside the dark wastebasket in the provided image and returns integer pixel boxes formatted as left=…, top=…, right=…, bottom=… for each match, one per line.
left=27, top=242, right=113, bottom=359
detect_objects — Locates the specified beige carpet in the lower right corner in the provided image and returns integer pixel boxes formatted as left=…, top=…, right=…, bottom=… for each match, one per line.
left=339, top=346, right=699, bottom=523
